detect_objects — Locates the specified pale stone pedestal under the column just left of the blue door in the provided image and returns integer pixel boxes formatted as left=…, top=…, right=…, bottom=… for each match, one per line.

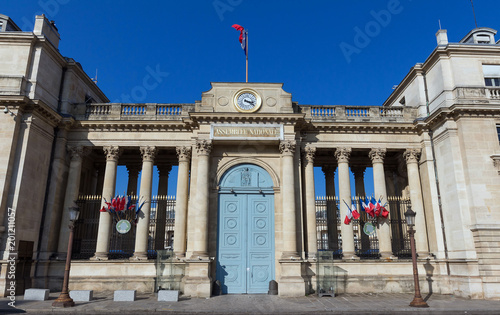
left=184, top=259, right=212, bottom=298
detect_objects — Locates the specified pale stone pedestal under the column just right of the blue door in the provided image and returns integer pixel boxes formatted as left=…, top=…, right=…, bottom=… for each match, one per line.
left=278, top=260, right=306, bottom=297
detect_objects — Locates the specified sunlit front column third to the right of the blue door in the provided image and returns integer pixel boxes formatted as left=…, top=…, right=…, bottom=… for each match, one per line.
left=335, top=148, right=357, bottom=259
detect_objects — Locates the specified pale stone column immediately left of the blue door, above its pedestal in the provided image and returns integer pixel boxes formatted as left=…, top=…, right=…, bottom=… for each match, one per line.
left=188, top=140, right=212, bottom=259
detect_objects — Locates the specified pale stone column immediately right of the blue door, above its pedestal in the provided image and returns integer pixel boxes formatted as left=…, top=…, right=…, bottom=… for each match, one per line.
left=280, top=140, right=300, bottom=259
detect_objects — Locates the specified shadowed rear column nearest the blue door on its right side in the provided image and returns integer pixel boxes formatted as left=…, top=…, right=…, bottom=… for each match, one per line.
left=322, top=165, right=339, bottom=251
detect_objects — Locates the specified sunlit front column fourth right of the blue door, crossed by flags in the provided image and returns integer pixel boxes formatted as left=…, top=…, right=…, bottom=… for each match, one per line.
left=369, top=148, right=395, bottom=258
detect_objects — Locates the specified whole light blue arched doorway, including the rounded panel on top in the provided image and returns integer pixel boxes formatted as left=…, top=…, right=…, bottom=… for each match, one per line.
left=216, top=164, right=275, bottom=294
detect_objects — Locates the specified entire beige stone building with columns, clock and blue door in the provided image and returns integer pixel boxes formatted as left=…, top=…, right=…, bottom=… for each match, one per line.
left=0, top=15, right=500, bottom=299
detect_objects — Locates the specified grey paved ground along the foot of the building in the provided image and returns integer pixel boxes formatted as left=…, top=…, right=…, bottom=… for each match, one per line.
left=0, top=292, right=500, bottom=315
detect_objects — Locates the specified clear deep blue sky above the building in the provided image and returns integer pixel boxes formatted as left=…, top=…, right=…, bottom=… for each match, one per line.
left=0, top=0, right=500, bottom=198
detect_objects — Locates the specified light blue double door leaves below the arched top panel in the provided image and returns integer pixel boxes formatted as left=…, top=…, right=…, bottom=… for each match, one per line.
left=217, top=193, right=274, bottom=294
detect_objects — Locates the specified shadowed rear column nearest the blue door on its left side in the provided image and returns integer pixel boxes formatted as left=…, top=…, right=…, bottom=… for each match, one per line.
left=155, top=165, right=172, bottom=250
